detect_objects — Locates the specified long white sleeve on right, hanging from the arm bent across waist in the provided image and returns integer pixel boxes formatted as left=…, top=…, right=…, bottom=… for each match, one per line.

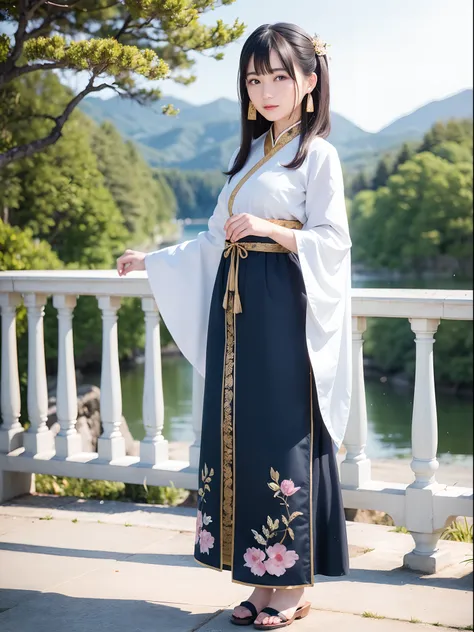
left=294, top=139, right=352, bottom=447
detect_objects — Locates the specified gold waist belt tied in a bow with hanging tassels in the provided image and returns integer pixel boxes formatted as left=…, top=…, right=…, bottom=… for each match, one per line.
left=222, top=219, right=303, bottom=314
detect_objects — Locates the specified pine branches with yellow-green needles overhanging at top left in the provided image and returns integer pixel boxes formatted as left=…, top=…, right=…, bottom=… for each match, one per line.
left=0, top=0, right=245, bottom=167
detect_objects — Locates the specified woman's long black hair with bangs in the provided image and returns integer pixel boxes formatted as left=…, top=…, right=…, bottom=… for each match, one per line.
left=224, top=22, right=331, bottom=179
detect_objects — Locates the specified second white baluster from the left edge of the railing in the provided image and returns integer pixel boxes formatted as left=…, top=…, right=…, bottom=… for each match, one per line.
left=23, top=293, right=54, bottom=456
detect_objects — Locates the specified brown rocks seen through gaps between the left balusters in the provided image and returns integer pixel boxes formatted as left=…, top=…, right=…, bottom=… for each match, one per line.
left=47, top=384, right=140, bottom=456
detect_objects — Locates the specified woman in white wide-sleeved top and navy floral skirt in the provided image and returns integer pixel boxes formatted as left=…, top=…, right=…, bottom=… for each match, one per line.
left=117, top=23, right=351, bottom=630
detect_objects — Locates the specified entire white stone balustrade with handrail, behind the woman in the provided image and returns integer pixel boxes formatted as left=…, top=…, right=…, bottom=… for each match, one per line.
left=0, top=270, right=473, bottom=573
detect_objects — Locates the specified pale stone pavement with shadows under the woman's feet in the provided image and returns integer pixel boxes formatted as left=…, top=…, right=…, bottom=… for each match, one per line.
left=0, top=495, right=473, bottom=632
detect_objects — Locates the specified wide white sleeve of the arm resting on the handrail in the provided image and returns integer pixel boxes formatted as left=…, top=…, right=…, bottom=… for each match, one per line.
left=145, top=170, right=232, bottom=376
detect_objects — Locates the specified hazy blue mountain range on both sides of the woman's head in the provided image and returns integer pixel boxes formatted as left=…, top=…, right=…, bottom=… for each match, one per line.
left=81, top=89, right=473, bottom=171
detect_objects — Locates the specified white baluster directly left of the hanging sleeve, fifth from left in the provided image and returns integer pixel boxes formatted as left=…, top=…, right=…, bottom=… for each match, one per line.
left=140, top=298, right=168, bottom=465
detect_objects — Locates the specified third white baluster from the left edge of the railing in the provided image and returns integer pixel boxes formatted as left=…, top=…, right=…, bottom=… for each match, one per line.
left=53, top=294, right=82, bottom=459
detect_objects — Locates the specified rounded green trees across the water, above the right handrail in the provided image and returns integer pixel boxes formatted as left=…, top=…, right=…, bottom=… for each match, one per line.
left=351, top=123, right=473, bottom=272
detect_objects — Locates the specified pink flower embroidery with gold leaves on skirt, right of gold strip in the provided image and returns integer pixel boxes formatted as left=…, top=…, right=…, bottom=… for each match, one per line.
left=244, top=467, right=303, bottom=577
